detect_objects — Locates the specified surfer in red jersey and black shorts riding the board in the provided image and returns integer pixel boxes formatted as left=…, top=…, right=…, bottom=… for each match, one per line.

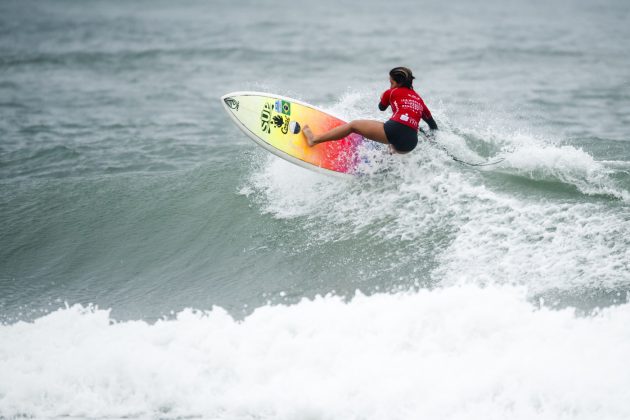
left=302, top=67, right=438, bottom=154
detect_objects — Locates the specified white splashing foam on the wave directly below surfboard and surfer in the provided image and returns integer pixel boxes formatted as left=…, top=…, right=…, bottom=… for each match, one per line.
left=246, top=146, right=630, bottom=293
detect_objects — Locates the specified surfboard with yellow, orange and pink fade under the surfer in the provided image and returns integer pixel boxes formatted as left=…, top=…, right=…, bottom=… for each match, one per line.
left=221, top=92, right=366, bottom=177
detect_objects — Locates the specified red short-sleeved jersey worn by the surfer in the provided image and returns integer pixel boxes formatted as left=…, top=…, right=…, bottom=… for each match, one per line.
left=381, top=87, right=433, bottom=130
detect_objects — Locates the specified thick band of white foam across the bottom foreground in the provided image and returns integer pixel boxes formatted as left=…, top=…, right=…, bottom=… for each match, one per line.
left=0, top=285, right=630, bottom=420
